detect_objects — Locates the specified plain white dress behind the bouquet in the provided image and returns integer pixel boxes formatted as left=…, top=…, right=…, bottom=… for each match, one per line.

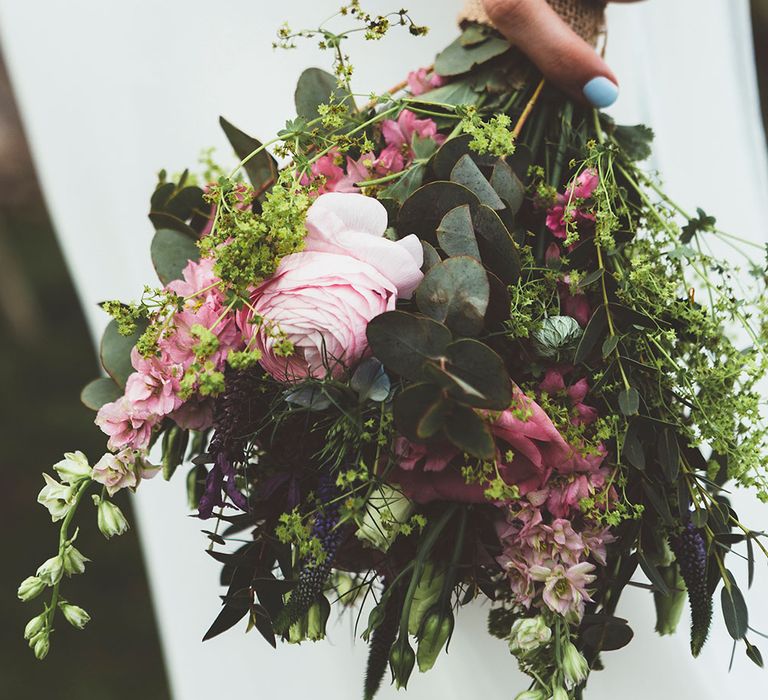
left=0, top=0, right=768, bottom=700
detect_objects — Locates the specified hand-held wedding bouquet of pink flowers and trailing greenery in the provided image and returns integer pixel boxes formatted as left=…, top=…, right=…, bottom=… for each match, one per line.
left=19, top=2, right=768, bottom=700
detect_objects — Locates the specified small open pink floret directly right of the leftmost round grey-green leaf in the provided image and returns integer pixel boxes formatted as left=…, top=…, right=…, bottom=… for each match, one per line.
left=125, top=348, right=182, bottom=416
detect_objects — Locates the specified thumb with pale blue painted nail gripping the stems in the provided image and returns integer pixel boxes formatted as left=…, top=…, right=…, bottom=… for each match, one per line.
left=483, top=0, right=619, bottom=107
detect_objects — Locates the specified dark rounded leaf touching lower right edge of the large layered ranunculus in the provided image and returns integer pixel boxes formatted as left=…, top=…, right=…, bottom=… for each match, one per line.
left=366, top=311, right=451, bottom=379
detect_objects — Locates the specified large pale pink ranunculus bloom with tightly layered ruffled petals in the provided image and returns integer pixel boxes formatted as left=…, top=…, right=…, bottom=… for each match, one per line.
left=246, top=253, right=397, bottom=381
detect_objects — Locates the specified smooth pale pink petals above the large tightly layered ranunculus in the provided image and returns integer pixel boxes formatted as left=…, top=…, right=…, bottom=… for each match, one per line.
left=304, top=192, right=424, bottom=299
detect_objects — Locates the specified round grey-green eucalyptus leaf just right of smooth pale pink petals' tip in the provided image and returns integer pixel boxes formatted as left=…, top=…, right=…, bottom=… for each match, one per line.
left=416, top=255, right=490, bottom=336
